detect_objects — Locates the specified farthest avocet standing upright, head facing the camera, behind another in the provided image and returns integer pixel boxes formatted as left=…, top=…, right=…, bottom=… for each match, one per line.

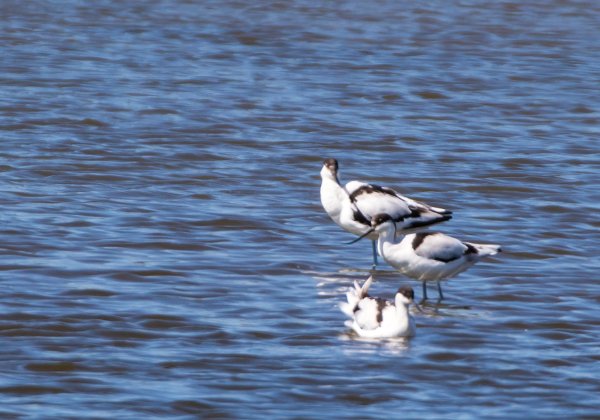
left=321, top=158, right=452, bottom=268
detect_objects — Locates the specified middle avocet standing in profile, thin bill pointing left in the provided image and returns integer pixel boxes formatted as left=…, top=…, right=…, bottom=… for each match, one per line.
left=359, top=214, right=502, bottom=299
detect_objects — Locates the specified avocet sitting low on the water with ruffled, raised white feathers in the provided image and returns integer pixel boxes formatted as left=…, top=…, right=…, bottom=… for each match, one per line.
left=340, top=276, right=416, bottom=338
